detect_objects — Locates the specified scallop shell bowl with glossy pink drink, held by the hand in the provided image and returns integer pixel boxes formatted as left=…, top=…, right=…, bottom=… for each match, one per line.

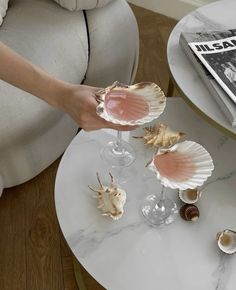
left=96, top=82, right=166, bottom=125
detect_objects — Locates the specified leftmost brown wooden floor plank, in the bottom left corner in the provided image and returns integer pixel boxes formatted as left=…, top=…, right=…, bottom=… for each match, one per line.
left=0, top=186, right=26, bottom=290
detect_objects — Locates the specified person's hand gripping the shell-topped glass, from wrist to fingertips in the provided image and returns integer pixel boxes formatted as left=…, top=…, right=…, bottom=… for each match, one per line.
left=58, top=85, right=136, bottom=131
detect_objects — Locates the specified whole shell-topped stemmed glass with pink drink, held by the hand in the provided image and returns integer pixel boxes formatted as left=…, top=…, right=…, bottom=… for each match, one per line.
left=97, top=82, right=166, bottom=167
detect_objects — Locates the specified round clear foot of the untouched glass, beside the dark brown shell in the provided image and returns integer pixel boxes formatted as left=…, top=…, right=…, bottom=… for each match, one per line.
left=141, top=194, right=178, bottom=226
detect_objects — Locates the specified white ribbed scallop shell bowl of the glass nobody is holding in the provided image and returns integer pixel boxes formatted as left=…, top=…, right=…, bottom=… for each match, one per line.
left=147, top=141, right=214, bottom=190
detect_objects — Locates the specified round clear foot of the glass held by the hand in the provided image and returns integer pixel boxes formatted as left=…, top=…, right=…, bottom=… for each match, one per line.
left=101, top=141, right=135, bottom=166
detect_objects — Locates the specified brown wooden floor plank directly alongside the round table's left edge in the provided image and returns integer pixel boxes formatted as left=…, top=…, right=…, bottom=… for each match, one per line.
left=25, top=162, right=64, bottom=290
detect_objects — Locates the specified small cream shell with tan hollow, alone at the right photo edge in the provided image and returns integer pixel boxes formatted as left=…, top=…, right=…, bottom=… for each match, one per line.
left=216, top=229, right=236, bottom=254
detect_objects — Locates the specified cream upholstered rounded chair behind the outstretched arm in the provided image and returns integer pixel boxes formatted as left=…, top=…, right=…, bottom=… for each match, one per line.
left=0, top=0, right=138, bottom=195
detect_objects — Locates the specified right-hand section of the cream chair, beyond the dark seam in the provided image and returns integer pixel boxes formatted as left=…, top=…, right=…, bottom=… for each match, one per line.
left=83, top=0, right=139, bottom=87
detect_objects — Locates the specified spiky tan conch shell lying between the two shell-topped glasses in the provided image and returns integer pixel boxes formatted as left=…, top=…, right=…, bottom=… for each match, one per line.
left=134, top=123, right=185, bottom=148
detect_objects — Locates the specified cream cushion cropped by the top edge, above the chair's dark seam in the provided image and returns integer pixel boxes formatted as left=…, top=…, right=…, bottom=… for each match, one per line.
left=54, top=0, right=112, bottom=11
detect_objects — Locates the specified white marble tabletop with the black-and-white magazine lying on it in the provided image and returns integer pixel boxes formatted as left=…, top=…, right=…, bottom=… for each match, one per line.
left=167, top=0, right=236, bottom=139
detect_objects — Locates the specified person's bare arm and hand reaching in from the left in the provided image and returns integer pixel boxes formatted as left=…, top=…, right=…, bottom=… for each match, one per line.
left=0, top=42, right=134, bottom=131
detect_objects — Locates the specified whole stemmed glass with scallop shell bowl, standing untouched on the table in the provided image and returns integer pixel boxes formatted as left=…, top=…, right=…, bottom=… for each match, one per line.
left=141, top=141, right=214, bottom=226
